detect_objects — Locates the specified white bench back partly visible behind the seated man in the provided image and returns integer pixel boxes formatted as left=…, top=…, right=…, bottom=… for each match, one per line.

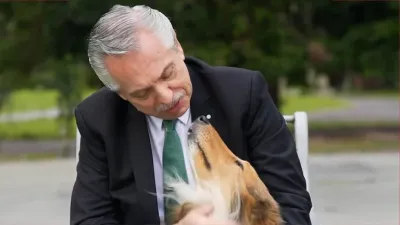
left=76, top=112, right=317, bottom=225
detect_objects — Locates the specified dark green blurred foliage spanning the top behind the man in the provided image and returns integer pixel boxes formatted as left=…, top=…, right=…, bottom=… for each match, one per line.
left=0, top=0, right=398, bottom=114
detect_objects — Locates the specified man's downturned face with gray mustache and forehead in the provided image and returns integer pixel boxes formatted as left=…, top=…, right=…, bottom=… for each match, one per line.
left=105, top=32, right=192, bottom=119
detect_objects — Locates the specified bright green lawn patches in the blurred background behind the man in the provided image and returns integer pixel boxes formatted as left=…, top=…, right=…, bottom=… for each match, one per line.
left=0, top=90, right=347, bottom=140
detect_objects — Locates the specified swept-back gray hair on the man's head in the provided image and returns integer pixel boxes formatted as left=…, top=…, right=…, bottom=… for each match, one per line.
left=88, top=5, right=175, bottom=91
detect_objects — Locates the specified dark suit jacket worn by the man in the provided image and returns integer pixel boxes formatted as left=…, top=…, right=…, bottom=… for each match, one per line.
left=70, top=57, right=311, bottom=225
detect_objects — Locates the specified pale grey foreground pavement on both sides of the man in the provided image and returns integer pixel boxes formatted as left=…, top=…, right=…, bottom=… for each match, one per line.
left=0, top=153, right=399, bottom=225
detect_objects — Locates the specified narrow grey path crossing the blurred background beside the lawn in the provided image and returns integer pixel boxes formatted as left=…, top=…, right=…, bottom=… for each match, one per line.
left=0, top=97, right=399, bottom=122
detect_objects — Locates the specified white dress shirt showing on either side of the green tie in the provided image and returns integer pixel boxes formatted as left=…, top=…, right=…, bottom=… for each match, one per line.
left=146, top=109, right=193, bottom=224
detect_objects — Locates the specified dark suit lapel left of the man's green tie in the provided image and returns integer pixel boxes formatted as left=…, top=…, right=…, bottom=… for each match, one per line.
left=126, top=104, right=160, bottom=224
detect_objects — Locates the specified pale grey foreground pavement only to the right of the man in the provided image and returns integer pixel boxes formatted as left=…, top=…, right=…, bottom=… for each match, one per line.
left=310, top=153, right=399, bottom=225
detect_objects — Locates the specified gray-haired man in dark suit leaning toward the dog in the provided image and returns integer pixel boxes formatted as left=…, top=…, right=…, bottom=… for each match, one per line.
left=70, top=5, right=311, bottom=225
